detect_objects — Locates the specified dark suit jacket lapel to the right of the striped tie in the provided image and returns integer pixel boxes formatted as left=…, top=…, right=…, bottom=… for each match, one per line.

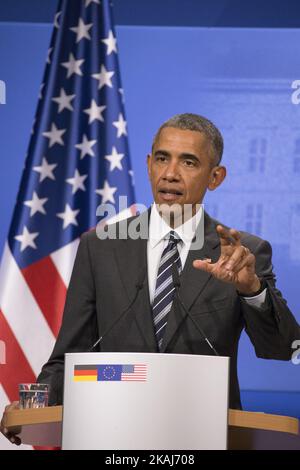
left=162, top=212, right=220, bottom=352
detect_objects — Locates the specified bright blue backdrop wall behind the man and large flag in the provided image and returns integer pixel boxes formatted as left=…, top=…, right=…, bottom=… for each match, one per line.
left=0, top=23, right=300, bottom=416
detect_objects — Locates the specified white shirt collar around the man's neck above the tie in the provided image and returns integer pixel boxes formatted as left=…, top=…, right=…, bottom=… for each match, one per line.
left=149, top=203, right=203, bottom=248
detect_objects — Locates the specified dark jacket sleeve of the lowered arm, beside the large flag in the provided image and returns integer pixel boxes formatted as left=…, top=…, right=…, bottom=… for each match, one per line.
left=37, top=234, right=98, bottom=405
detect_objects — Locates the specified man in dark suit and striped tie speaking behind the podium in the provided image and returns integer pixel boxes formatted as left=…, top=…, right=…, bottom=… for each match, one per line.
left=1, top=114, right=300, bottom=444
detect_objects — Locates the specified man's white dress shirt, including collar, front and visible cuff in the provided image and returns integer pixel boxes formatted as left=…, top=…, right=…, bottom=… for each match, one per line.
left=147, top=204, right=266, bottom=307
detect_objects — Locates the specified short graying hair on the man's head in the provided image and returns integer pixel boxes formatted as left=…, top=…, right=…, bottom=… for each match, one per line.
left=152, top=113, right=224, bottom=165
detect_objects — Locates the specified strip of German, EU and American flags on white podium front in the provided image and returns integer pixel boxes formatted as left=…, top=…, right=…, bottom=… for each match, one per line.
left=73, top=364, right=147, bottom=382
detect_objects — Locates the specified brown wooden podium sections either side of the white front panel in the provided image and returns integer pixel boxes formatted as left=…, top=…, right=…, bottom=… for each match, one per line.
left=4, top=406, right=300, bottom=450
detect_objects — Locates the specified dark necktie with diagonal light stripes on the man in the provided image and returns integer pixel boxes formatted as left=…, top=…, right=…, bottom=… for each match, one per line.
left=152, top=231, right=182, bottom=351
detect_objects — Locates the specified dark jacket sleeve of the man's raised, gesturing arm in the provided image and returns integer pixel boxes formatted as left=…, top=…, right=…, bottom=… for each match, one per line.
left=240, top=240, right=300, bottom=360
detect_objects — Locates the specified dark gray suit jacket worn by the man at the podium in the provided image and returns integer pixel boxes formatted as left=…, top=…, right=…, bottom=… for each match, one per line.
left=38, top=213, right=300, bottom=408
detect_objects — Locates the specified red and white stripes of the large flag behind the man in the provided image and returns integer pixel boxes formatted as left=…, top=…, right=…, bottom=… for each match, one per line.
left=0, top=206, right=135, bottom=449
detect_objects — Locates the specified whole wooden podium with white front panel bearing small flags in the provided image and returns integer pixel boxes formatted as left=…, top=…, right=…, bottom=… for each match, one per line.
left=4, top=353, right=300, bottom=450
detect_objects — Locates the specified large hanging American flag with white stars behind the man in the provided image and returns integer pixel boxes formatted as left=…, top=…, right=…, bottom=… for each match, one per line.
left=0, top=0, right=134, bottom=436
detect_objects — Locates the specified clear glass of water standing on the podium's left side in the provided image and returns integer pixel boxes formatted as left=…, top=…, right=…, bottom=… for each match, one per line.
left=19, top=384, right=50, bottom=409
